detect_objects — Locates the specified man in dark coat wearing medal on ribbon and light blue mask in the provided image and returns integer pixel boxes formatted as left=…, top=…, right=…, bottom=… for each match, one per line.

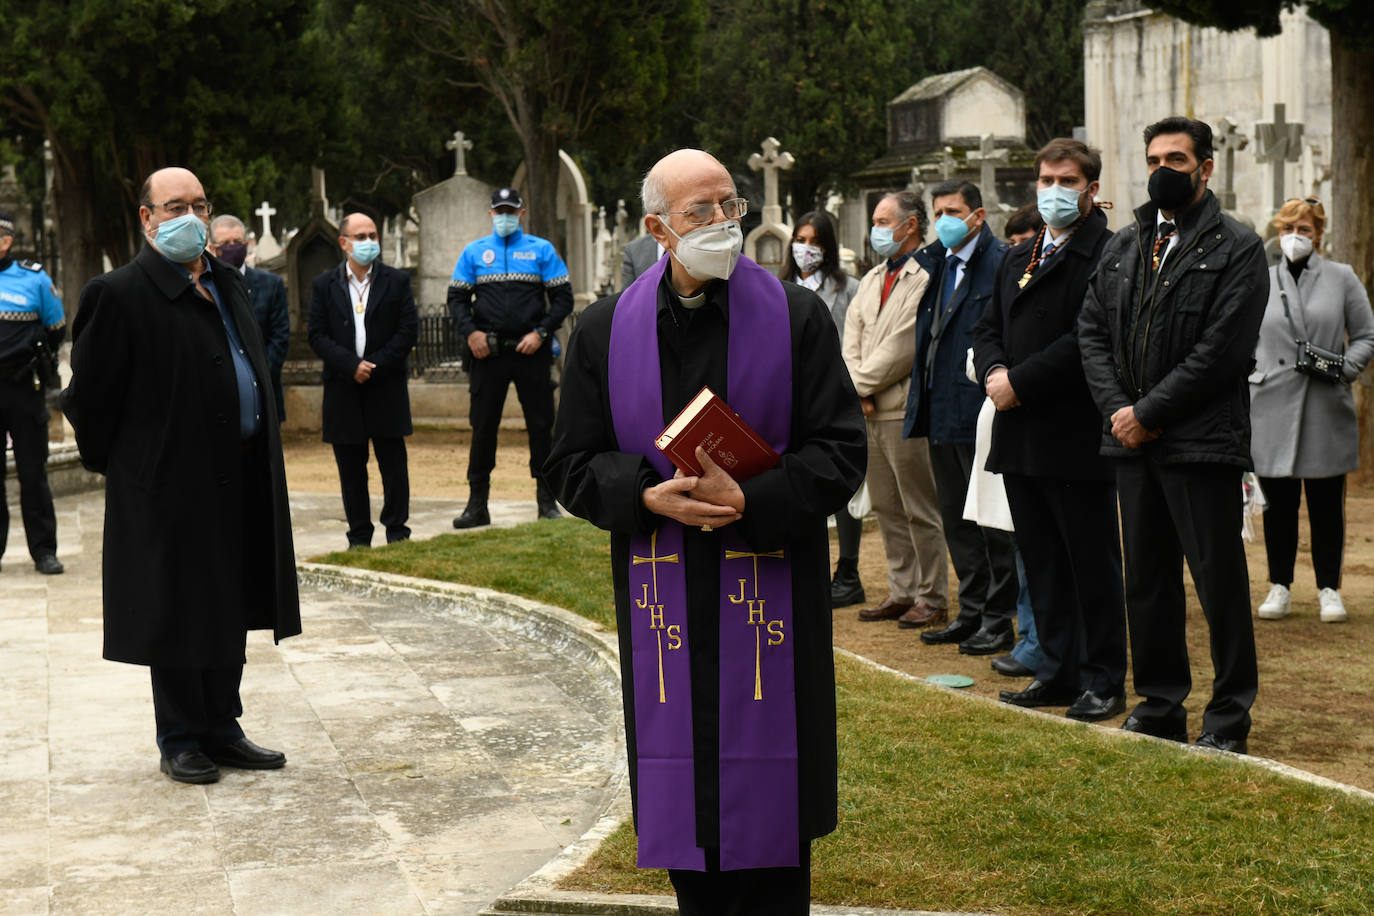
left=973, top=139, right=1125, bottom=721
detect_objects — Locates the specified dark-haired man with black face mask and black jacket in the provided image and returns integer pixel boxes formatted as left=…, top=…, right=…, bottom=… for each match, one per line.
left=1079, top=117, right=1268, bottom=754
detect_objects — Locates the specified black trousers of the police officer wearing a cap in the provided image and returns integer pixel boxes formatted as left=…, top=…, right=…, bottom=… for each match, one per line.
left=467, top=342, right=554, bottom=486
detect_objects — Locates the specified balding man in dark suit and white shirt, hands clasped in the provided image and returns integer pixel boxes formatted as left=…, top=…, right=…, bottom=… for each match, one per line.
left=308, top=213, right=419, bottom=549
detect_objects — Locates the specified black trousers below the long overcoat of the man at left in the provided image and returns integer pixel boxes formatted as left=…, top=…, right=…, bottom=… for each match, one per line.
left=151, top=665, right=243, bottom=758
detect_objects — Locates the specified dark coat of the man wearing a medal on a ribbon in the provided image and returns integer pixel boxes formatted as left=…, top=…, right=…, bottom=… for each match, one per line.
left=973, top=207, right=1113, bottom=481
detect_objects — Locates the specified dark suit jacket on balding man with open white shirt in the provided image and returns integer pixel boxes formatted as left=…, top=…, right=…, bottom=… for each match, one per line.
left=306, top=261, right=419, bottom=442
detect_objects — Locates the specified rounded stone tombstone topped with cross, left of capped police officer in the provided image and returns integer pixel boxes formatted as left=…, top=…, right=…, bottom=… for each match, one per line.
left=408, top=132, right=496, bottom=314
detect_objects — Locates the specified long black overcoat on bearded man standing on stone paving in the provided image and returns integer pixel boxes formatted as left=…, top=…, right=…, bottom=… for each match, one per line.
left=62, top=246, right=301, bottom=667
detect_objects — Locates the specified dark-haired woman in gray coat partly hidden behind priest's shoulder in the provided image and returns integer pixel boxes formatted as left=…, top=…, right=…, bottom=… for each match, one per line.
left=778, top=210, right=864, bottom=607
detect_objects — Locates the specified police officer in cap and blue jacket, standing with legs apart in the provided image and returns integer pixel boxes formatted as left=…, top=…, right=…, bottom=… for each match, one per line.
left=448, top=188, right=573, bottom=529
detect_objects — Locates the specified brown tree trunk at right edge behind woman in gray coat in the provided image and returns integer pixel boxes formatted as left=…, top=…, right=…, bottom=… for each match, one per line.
left=1329, top=30, right=1374, bottom=485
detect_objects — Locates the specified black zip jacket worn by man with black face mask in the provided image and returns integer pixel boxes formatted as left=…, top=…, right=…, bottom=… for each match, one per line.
left=1079, top=191, right=1270, bottom=468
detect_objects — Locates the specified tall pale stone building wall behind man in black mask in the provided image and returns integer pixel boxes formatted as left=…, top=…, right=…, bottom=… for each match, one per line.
left=1083, top=0, right=1342, bottom=235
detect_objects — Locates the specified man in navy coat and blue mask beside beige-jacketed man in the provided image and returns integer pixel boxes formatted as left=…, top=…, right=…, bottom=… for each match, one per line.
left=901, top=181, right=1020, bottom=655
